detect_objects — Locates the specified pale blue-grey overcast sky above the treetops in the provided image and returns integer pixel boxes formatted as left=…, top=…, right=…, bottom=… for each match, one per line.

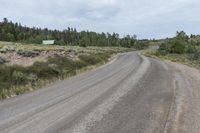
left=0, top=0, right=200, bottom=39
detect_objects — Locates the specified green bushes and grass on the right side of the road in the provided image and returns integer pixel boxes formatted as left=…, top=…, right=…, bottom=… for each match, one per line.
left=145, top=31, right=200, bottom=68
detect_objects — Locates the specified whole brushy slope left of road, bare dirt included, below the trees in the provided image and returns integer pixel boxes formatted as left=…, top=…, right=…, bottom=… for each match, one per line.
left=0, top=42, right=133, bottom=99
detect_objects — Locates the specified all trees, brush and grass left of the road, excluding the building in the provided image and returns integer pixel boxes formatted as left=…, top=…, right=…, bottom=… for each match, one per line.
left=0, top=18, right=148, bottom=99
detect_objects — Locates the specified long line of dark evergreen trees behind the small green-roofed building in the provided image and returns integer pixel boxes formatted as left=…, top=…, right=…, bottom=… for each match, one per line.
left=0, top=18, right=146, bottom=49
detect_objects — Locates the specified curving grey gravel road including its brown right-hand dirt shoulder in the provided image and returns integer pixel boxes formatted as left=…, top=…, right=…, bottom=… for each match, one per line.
left=0, top=53, right=200, bottom=133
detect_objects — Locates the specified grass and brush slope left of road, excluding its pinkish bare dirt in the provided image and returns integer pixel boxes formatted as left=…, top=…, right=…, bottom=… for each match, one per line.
left=0, top=42, right=133, bottom=99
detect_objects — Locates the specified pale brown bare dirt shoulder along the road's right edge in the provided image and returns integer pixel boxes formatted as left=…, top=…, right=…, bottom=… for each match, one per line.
left=166, top=62, right=200, bottom=133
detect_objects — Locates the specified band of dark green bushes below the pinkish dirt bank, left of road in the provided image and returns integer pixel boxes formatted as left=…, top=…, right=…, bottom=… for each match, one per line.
left=0, top=54, right=110, bottom=99
